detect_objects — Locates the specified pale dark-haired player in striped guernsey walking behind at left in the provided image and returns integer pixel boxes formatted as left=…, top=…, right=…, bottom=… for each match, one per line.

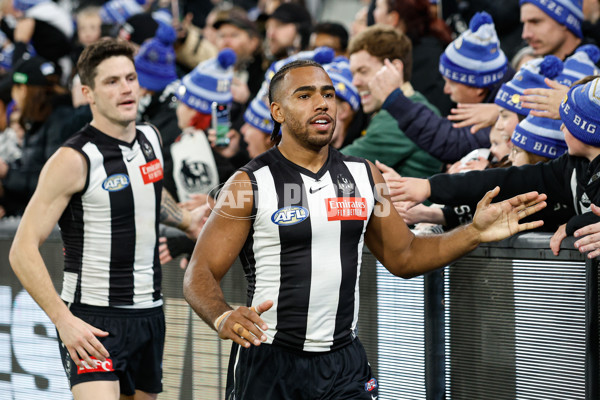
left=10, top=39, right=200, bottom=400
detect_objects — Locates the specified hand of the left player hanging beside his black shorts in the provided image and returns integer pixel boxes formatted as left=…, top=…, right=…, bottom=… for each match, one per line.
left=56, top=314, right=110, bottom=367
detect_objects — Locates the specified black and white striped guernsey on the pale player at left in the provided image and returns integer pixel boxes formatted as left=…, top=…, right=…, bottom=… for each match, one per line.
left=59, top=125, right=163, bottom=308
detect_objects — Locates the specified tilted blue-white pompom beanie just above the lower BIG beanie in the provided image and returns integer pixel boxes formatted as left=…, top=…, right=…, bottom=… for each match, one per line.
left=494, top=55, right=563, bottom=115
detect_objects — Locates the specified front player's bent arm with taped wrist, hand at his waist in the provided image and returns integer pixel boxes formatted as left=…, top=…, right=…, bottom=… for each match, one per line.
left=183, top=172, right=273, bottom=347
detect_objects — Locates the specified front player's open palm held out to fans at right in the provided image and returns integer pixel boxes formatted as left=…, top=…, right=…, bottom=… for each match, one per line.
left=473, top=186, right=546, bottom=243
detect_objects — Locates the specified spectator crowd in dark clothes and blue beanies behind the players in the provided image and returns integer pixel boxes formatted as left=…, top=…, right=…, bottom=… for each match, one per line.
left=0, top=0, right=600, bottom=263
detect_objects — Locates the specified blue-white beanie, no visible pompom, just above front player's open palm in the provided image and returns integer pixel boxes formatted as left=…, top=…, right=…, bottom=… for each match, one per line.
left=510, top=115, right=567, bottom=159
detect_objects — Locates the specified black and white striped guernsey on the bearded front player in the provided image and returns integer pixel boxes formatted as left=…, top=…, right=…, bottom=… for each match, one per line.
left=240, top=147, right=374, bottom=352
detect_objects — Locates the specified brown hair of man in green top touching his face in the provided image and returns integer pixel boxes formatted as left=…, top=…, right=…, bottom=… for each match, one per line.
left=348, top=24, right=412, bottom=82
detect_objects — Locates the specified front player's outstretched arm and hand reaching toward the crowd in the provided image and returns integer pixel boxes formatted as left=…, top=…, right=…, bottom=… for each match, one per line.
left=365, top=160, right=546, bottom=278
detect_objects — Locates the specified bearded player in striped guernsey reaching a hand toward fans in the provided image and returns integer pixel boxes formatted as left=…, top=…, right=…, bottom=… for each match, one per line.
left=184, top=57, right=545, bottom=400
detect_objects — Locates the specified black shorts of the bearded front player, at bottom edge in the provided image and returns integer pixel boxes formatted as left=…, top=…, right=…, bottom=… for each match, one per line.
left=225, top=338, right=378, bottom=400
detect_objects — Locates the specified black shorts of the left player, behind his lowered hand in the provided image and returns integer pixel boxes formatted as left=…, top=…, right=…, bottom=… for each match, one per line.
left=58, top=304, right=165, bottom=396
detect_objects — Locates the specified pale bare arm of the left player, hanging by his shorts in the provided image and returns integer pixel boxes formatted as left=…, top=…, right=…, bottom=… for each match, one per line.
left=9, top=147, right=109, bottom=365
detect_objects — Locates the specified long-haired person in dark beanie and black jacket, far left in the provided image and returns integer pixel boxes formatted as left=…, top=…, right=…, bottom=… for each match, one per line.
left=0, top=56, right=89, bottom=215
